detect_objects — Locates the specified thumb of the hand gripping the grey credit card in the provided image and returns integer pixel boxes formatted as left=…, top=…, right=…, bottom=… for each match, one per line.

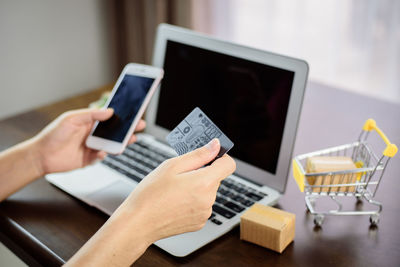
left=177, top=138, right=221, bottom=172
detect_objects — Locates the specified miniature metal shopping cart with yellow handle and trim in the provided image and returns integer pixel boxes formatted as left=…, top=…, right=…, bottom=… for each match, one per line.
left=293, top=119, right=397, bottom=226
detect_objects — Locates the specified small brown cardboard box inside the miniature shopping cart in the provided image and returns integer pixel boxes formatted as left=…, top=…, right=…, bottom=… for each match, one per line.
left=307, top=156, right=357, bottom=193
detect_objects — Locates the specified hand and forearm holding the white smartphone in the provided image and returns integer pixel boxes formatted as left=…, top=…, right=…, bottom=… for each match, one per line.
left=0, top=109, right=145, bottom=201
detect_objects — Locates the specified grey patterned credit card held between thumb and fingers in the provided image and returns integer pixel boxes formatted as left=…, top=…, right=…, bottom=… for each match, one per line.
left=167, top=107, right=233, bottom=158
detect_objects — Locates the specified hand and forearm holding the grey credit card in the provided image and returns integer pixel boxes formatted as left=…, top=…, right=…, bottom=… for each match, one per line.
left=67, top=139, right=236, bottom=266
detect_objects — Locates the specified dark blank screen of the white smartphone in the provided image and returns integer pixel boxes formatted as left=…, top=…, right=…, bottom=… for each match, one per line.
left=93, top=74, right=154, bottom=143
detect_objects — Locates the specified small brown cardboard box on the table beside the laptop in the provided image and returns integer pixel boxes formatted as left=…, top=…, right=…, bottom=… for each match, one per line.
left=240, top=203, right=296, bottom=253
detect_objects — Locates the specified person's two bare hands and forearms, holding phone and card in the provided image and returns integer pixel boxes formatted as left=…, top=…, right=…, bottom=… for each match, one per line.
left=0, top=109, right=236, bottom=266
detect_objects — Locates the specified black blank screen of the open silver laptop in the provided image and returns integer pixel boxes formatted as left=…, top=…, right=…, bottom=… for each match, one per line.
left=155, top=40, right=294, bottom=174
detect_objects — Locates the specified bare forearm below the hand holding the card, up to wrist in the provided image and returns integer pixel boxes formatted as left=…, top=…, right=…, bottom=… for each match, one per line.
left=66, top=205, right=153, bottom=266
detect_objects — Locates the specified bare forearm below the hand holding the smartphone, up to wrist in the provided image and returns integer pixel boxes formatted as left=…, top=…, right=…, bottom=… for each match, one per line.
left=0, top=139, right=44, bottom=201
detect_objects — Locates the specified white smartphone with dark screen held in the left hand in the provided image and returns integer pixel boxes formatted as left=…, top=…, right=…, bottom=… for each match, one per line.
left=86, top=63, right=164, bottom=154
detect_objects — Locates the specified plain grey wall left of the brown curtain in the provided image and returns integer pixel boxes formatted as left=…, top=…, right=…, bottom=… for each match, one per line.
left=0, top=0, right=115, bottom=119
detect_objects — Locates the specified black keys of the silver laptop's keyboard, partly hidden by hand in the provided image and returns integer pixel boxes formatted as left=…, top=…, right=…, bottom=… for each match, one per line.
left=102, top=140, right=267, bottom=225
